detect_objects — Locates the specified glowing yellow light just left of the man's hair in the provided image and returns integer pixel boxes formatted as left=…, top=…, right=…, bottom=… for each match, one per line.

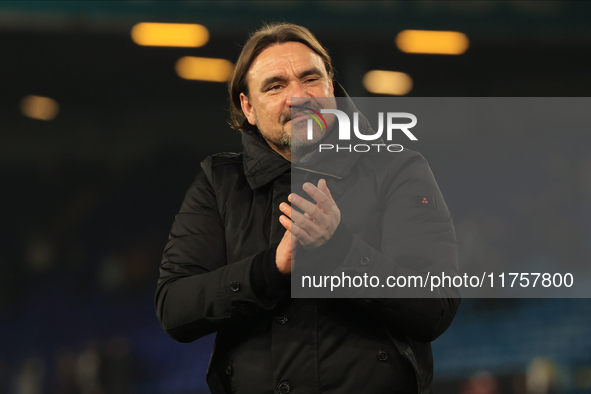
left=176, top=56, right=234, bottom=82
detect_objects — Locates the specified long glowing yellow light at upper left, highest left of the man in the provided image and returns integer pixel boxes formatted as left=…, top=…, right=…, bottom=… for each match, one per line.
left=131, top=23, right=209, bottom=47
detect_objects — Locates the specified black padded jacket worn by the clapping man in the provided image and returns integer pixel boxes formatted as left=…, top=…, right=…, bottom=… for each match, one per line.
left=156, top=87, right=460, bottom=394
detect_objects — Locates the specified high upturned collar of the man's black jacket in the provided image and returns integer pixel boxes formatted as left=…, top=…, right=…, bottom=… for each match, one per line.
left=242, top=82, right=371, bottom=190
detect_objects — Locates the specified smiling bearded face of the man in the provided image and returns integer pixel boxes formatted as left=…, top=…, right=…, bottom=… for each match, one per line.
left=240, top=42, right=336, bottom=154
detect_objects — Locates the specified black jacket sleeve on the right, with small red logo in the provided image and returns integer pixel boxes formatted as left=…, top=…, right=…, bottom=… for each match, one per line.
left=300, top=151, right=460, bottom=342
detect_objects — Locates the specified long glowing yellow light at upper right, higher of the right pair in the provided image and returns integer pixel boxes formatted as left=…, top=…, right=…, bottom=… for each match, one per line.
left=396, top=30, right=469, bottom=55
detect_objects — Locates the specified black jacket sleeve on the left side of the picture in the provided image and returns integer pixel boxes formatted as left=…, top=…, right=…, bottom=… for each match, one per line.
left=155, top=158, right=288, bottom=342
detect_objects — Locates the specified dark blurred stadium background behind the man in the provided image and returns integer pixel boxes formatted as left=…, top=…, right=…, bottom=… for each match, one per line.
left=0, top=1, right=591, bottom=394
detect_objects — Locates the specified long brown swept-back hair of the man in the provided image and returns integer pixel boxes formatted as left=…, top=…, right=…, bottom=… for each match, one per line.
left=228, top=23, right=334, bottom=131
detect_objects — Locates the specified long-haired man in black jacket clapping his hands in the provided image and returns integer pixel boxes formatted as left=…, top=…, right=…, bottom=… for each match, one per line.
left=156, top=24, right=459, bottom=394
